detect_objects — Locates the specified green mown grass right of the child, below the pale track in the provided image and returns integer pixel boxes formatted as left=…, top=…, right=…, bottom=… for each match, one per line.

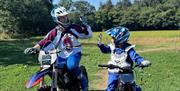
left=138, top=50, right=180, bottom=91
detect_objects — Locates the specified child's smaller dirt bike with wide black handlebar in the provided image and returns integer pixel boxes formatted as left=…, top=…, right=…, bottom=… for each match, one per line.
left=98, top=64, right=150, bottom=91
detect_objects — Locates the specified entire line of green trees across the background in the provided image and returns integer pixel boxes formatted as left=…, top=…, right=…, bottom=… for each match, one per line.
left=0, top=0, right=180, bottom=35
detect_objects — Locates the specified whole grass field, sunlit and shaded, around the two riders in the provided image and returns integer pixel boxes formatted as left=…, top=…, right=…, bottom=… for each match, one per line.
left=0, top=31, right=180, bottom=91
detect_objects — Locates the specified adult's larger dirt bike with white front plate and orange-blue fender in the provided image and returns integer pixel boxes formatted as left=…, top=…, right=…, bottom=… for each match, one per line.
left=26, top=41, right=88, bottom=91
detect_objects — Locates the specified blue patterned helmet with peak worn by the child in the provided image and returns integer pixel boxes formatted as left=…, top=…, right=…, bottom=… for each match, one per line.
left=106, top=26, right=130, bottom=45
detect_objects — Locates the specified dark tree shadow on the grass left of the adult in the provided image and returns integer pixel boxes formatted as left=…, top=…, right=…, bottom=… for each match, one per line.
left=0, top=40, right=38, bottom=66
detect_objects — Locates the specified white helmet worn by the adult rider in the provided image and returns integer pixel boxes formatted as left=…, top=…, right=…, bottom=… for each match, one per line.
left=51, top=7, right=69, bottom=25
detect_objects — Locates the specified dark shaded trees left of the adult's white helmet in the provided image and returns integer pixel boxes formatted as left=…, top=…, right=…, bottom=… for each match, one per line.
left=0, top=0, right=52, bottom=34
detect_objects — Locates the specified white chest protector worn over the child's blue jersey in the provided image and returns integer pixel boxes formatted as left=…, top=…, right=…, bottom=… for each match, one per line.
left=108, top=44, right=135, bottom=73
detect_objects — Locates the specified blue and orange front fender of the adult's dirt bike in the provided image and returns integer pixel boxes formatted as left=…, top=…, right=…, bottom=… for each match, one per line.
left=26, top=68, right=50, bottom=88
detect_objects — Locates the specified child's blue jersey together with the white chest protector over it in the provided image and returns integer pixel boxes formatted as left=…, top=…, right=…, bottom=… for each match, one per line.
left=98, top=43, right=144, bottom=72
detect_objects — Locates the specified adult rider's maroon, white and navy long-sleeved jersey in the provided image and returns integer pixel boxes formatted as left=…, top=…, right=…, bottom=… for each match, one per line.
left=38, top=24, right=92, bottom=58
